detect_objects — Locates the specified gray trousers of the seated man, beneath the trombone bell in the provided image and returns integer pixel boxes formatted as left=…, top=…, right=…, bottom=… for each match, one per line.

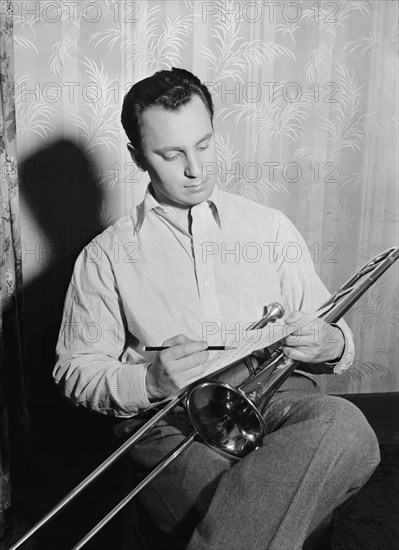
left=130, top=380, right=380, bottom=550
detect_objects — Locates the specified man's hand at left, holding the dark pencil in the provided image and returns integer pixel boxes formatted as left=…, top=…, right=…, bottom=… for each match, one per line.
left=146, top=334, right=209, bottom=401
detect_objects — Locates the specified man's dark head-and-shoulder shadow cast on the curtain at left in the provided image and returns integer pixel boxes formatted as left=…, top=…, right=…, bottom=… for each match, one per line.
left=20, top=140, right=104, bottom=410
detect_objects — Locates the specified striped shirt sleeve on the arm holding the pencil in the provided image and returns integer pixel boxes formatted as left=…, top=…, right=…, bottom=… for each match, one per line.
left=53, top=240, right=150, bottom=417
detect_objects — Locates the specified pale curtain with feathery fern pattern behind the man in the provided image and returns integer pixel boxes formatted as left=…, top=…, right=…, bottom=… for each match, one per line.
left=13, top=0, right=399, bottom=393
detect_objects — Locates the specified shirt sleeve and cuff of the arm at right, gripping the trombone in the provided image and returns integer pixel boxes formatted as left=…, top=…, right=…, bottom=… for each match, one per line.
left=275, top=213, right=355, bottom=374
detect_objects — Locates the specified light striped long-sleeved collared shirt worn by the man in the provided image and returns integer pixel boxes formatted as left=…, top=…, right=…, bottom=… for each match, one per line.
left=53, top=186, right=354, bottom=417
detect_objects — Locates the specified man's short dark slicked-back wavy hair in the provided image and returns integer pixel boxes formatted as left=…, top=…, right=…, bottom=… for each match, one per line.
left=121, top=67, right=213, bottom=153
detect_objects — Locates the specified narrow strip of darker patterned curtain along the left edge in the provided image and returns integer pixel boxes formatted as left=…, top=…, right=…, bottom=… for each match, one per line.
left=0, top=2, right=28, bottom=535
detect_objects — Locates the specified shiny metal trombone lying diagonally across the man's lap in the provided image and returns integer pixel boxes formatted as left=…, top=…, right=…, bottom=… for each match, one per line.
left=9, top=247, right=399, bottom=550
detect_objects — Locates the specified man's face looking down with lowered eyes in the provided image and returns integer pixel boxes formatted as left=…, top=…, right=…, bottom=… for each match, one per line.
left=133, top=95, right=216, bottom=208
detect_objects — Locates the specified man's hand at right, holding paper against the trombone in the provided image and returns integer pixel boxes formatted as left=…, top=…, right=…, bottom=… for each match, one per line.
left=283, top=311, right=345, bottom=363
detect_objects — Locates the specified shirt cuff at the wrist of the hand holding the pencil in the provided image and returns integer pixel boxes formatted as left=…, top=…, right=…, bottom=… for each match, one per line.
left=119, top=363, right=152, bottom=414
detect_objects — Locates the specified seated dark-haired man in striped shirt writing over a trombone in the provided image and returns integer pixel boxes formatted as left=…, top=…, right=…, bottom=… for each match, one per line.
left=54, top=68, right=379, bottom=550
